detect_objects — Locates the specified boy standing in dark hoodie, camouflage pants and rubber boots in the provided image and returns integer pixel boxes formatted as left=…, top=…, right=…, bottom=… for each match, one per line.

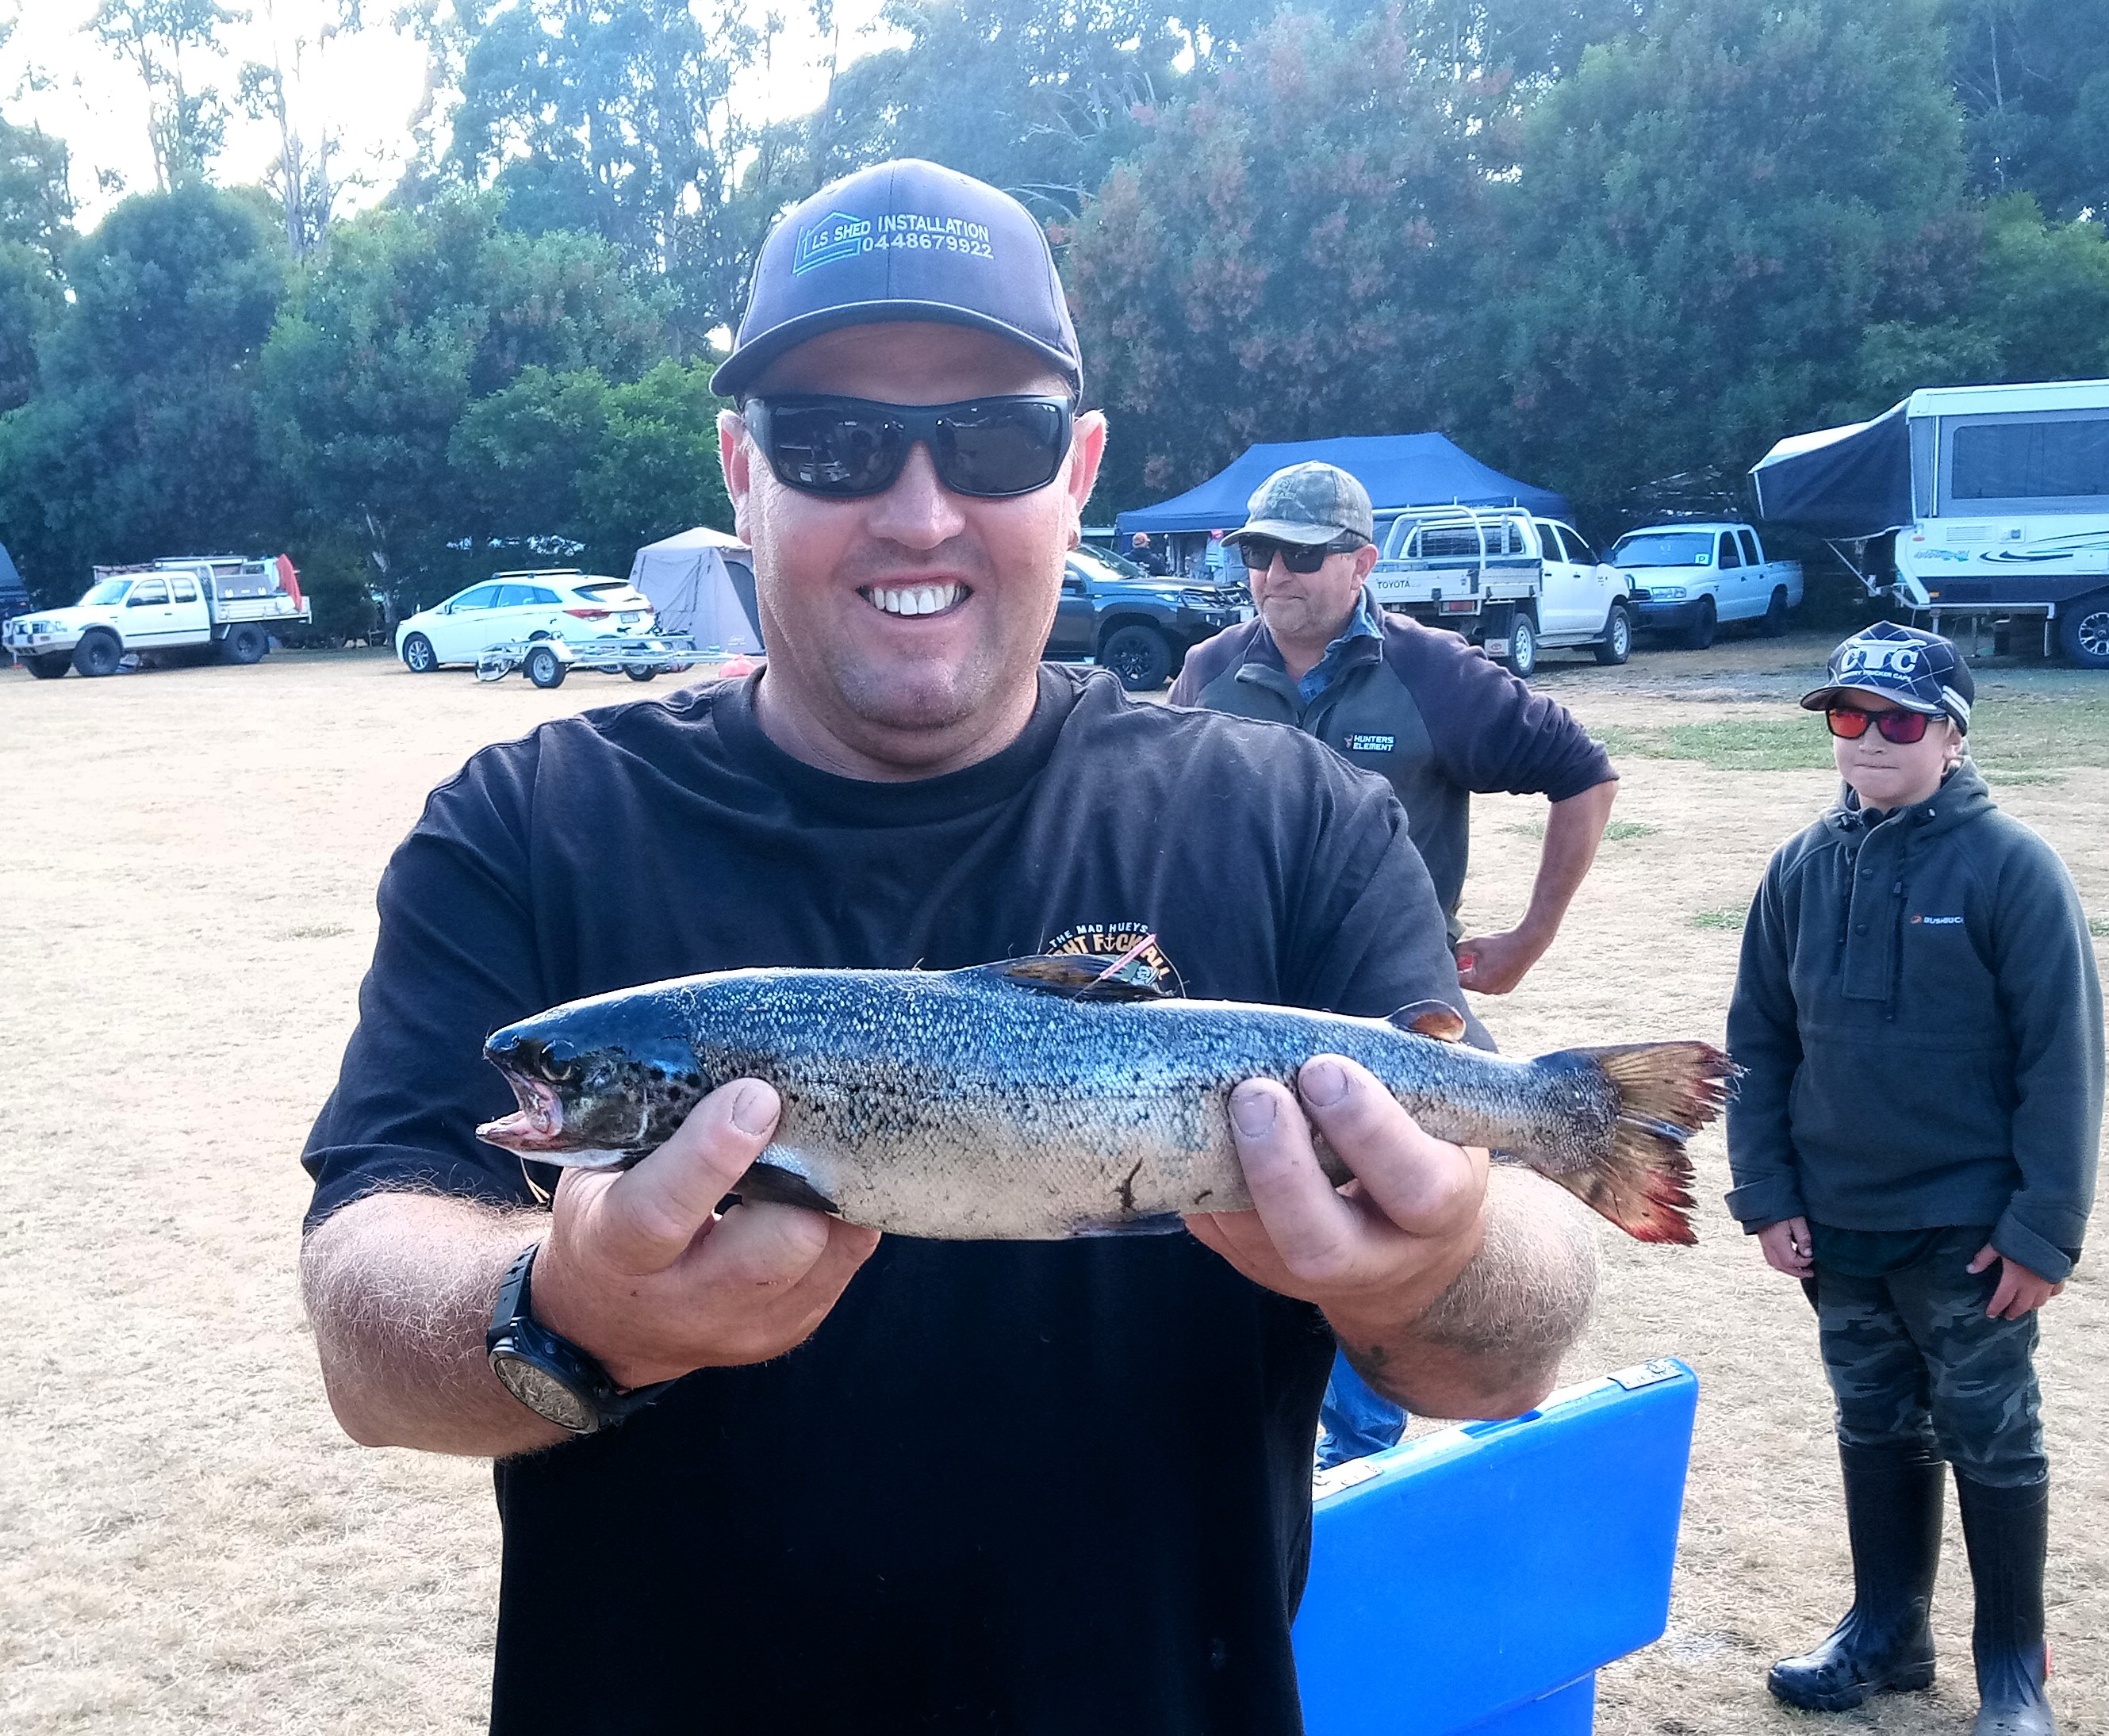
left=1727, top=623, right=2103, bottom=1736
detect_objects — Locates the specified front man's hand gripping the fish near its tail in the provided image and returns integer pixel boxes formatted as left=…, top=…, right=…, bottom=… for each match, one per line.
left=1187, top=1055, right=1487, bottom=1356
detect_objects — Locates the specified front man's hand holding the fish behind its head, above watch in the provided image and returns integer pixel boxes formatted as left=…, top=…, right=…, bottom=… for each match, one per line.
left=534, top=1080, right=880, bottom=1385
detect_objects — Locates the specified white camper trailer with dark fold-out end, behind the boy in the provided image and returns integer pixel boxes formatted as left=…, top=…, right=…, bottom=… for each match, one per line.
left=1750, top=380, right=2109, bottom=669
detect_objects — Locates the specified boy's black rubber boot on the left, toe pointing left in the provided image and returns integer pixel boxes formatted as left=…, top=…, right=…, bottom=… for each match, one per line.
left=1766, top=1441, right=1945, bottom=1713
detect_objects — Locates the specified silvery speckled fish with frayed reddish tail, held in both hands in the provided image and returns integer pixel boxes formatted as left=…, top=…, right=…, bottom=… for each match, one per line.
left=477, top=953, right=1735, bottom=1243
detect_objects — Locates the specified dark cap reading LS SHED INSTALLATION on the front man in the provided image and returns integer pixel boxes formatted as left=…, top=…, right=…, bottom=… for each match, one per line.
left=711, top=158, right=1084, bottom=399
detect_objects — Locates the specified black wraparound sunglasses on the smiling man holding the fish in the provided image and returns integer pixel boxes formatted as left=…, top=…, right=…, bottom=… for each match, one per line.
left=740, top=397, right=1076, bottom=500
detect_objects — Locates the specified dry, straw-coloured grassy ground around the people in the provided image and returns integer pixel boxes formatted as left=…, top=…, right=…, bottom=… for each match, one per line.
left=0, top=637, right=2109, bottom=1736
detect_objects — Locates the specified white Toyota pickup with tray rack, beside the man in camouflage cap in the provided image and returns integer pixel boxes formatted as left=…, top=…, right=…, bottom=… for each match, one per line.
left=1369, top=506, right=1635, bottom=675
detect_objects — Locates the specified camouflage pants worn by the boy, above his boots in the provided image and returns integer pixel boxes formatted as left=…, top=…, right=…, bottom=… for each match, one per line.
left=1803, top=1230, right=2050, bottom=1489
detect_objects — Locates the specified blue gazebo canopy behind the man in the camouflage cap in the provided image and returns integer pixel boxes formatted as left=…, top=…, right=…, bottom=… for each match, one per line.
left=1118, top=435, right=1567, bottom=542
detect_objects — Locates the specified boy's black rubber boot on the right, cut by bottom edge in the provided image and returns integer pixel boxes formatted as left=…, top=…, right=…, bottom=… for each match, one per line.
left=1955, top=1477, right=2058, bottom=1736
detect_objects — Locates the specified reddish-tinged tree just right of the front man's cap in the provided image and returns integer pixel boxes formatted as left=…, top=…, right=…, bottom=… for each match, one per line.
left=1067, top=13, right=1485, bottom=500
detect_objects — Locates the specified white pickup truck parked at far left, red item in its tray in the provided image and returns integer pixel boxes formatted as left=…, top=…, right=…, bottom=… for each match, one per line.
left=0, top=555, right=313, bottom=681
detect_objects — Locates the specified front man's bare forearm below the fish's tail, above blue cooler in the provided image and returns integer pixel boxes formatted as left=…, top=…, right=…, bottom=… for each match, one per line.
left=1329, top=1167, right=1597, bottom=1417
